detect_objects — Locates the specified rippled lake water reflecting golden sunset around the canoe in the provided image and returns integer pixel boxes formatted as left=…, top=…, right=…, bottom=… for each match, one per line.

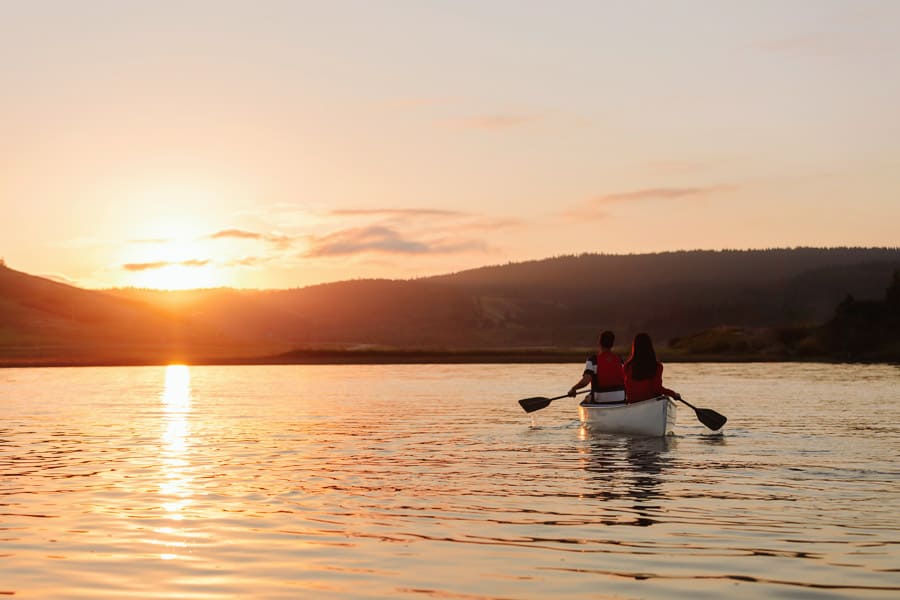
left=0, top=364, right=900, bottom=599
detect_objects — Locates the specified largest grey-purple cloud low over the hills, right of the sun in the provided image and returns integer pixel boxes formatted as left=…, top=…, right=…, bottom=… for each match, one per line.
left=305, top=226, right=485, bottom=258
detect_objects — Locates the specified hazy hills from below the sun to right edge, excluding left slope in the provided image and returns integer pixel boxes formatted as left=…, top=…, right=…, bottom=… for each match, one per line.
left=107, top=248, right=900, bottom=348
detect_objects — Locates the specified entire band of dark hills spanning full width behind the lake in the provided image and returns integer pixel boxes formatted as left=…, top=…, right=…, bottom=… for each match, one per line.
left=0, top=248, right=900, bottom=363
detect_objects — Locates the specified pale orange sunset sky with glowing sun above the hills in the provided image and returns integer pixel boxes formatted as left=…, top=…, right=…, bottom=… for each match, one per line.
left=0, top=0, right=900, bottom=288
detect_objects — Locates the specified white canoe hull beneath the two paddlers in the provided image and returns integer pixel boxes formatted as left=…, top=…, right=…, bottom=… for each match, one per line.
left=578, top=396, right=678, bottom=437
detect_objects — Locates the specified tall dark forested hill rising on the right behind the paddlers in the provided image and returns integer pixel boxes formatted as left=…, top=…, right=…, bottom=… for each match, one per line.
left=429, top=248, right=900, bottom=345
